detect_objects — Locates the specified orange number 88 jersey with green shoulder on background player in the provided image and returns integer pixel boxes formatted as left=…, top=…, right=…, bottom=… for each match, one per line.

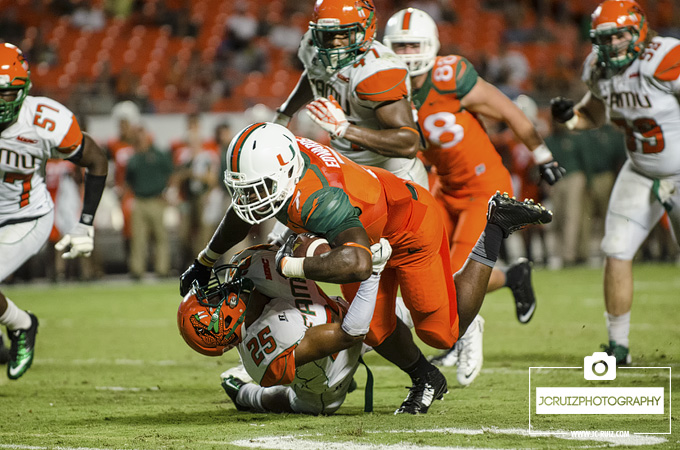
left=413, top=55, right=508, bottom=196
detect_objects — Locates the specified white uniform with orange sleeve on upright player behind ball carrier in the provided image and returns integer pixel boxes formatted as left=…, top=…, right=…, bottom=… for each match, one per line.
left=298, top=31, right=427, bottom=181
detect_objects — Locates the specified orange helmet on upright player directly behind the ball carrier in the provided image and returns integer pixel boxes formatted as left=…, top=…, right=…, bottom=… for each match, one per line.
left=309, top=0, right=376, bottom=70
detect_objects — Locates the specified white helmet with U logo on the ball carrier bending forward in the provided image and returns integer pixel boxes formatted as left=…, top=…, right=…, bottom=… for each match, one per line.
left=224, top=122, right=305, bottom=225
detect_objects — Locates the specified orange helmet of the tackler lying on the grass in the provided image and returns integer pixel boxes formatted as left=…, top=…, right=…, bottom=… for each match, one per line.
left=177, top=264, right=252, bottom=356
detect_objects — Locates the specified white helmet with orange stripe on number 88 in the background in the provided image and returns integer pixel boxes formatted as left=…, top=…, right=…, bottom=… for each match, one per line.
left=383, top=8, right=439, bottom=76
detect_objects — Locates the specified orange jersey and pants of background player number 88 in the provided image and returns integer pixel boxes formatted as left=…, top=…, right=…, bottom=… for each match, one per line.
left=413, top=55, right=512, bottom=272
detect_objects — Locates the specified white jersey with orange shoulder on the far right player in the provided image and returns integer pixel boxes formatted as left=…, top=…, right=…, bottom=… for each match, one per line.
left=583, top=37, right=680, bottom=178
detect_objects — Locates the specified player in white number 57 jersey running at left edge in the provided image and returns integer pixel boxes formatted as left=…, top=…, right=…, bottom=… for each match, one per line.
left=0, top=43, right=108, bottom=380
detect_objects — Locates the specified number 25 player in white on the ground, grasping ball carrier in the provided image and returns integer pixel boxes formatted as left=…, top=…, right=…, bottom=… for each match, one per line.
left=177, top=239, right=391, bottom=414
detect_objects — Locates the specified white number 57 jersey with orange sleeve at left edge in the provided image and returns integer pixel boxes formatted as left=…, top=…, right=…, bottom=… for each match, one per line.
left=0, top=96, right=83, bottom=226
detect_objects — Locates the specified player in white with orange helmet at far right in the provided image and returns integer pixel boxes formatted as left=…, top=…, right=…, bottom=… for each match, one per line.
left=551, top=0, right=680, bottom=364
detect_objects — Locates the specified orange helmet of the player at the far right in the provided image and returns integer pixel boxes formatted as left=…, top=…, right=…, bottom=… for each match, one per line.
left=590, top=0, right=647, bottom=75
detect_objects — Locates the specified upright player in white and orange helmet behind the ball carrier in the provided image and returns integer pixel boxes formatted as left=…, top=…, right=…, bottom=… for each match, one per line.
left=274, top=0, right=427, bottom=188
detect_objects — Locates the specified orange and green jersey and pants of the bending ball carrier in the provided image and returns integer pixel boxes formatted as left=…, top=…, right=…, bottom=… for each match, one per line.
left=276, top=137, right=458, bottom=349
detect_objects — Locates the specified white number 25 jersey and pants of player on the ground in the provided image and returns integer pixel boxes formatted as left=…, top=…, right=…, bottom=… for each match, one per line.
left=232, top=246, right=362, bottom=407
